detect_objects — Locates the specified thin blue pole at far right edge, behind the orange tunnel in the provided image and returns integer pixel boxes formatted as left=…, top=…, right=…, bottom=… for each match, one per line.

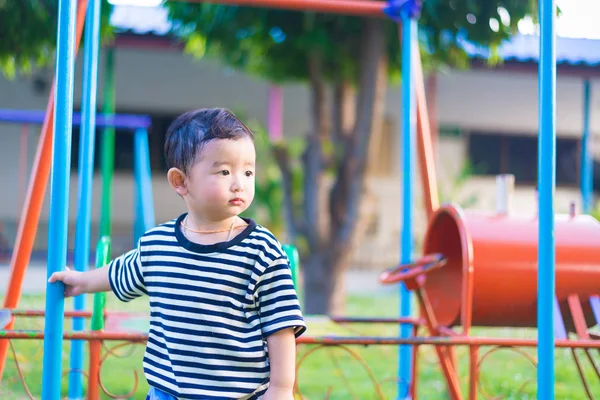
left=580, top=79, right=594, bottom=214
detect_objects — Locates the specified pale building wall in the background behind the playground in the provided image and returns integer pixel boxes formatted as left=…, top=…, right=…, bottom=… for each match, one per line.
left=0, top=48, right=600, bottom=258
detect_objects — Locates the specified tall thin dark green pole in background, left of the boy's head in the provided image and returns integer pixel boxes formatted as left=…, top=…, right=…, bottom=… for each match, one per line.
left=100, top=47, right=116, bottom=237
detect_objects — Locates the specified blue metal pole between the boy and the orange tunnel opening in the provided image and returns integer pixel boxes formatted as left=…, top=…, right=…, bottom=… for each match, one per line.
left=398, top=13, right=417, bottom=399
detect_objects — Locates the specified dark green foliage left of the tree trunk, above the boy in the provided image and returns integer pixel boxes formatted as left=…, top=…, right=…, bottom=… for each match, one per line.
left=167, top=3, right=380, bottom=82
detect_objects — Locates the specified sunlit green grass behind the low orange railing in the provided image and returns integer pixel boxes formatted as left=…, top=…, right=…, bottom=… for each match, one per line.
left=0, top=293, right=600, bottom=400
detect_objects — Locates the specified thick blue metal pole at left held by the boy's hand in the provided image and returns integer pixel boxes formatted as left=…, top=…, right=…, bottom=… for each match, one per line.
left=42, top=0, right=77, bottom=400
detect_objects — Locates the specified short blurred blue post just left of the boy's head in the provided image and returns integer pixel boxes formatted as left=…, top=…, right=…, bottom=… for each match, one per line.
left=133, top=129, right=155, bottom=244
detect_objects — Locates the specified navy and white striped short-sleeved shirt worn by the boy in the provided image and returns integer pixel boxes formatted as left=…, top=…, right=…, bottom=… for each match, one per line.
left=108, top=214, right=306, bottom=400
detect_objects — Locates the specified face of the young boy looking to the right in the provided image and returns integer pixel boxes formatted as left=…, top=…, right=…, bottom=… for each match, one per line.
left=186, top=137, right=256, bottom=221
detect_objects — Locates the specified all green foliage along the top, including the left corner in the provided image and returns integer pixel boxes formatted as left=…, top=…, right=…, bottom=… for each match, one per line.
left=0, top=0, right=537, bottom=82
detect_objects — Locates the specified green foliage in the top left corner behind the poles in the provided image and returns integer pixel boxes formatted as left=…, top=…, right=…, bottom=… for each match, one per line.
left=0, top=0, right=112, bottom=78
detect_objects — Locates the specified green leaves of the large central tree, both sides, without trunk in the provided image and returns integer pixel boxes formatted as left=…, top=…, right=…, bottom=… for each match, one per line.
left=167, top=0, right=537, bottom=82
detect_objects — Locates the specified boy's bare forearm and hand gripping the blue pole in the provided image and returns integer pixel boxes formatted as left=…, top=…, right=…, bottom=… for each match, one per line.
left=48, top=265, right=110, bottom=297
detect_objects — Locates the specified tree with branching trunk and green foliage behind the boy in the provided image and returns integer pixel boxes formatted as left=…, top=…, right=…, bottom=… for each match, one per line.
left=168, top=0, right=536, bottom=313
